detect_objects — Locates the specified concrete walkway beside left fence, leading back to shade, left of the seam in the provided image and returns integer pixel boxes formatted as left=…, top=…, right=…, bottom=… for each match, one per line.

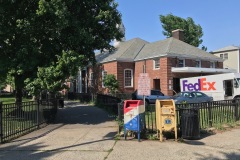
left=0, top=104, right=117, bottom=160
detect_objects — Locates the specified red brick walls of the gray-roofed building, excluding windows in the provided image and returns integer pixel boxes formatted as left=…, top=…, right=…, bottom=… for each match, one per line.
left=88, top=57, right=223, bottom=95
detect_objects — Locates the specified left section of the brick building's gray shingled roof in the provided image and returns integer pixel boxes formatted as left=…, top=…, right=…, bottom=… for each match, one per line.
left=95, top=38, right=149, bottom=63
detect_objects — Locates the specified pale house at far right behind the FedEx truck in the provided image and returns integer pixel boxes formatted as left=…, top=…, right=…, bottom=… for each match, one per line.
left=211, top=46, right=240, bottom=73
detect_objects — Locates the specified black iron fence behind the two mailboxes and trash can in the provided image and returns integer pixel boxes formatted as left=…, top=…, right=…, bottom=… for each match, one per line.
left=118, top=100, right=240, bottom=132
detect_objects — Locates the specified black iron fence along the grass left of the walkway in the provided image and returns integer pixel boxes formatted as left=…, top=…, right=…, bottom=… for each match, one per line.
left=0, top=99, right=64, bottom=143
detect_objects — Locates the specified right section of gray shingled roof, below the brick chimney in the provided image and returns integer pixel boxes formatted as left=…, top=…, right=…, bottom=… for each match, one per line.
left=135, top=37, right=223, bottom=61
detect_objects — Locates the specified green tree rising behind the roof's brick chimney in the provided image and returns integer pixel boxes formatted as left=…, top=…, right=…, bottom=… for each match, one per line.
left=160, top=14, right=206, bottom=50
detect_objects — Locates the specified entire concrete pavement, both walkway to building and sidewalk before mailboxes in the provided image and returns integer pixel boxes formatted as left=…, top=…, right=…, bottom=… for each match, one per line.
left=0, top=103, right=240, bottom=160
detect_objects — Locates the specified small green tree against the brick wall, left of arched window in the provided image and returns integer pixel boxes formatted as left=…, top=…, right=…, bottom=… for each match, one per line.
left=103, top=74, right=119, bottom=95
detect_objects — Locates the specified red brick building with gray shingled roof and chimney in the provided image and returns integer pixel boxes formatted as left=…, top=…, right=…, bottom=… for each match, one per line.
left=77, top=30, right=233, bottom=96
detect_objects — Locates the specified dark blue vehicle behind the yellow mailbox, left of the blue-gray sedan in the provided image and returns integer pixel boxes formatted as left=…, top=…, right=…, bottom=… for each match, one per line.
left=132, top=90, right=171, bottom=104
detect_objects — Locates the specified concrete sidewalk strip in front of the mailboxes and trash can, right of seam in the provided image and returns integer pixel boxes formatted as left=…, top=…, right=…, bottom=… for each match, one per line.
left=107, top=129, right=240, bottom=160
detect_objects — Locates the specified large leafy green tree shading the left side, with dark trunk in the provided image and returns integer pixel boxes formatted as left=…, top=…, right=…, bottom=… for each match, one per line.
left=0, top=0, right=123, bottom=102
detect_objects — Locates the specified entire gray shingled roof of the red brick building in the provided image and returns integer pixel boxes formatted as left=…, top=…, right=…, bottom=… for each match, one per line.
left=96, top=37, right=223, bottom=63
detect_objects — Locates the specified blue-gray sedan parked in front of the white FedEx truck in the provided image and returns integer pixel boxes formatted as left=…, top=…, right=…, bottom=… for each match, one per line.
left=172, top=91, right=213, bottom=104
